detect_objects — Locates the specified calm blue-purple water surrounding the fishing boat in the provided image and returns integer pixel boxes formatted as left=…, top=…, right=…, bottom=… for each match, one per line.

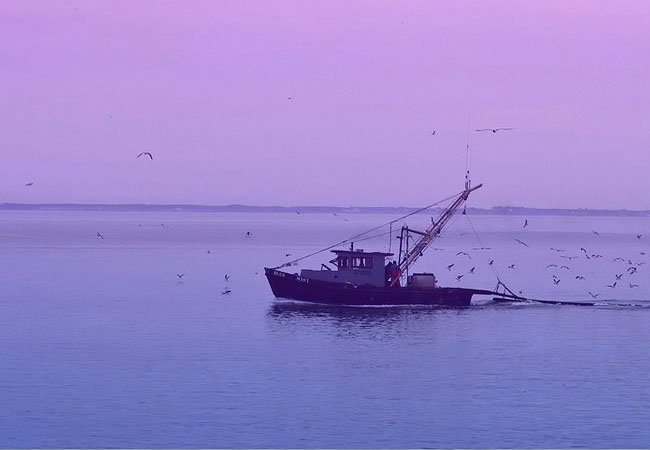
left=0, top=211, right=650, bottom=448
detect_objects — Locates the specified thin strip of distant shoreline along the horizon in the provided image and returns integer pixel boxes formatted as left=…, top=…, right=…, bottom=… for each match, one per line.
left=0, top=203, right=650, bottom=217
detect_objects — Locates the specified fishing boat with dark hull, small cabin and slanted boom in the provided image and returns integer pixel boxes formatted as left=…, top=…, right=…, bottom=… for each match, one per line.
left=264, top=180, right=517, bottom=306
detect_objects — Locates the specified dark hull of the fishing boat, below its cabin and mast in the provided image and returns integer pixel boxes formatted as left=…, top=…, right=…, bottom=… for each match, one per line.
left=264, top=268, right=492, bottom=306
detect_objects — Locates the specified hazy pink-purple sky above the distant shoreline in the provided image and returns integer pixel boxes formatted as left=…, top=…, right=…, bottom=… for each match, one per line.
left=0, top=0, right=650, bottom=209
